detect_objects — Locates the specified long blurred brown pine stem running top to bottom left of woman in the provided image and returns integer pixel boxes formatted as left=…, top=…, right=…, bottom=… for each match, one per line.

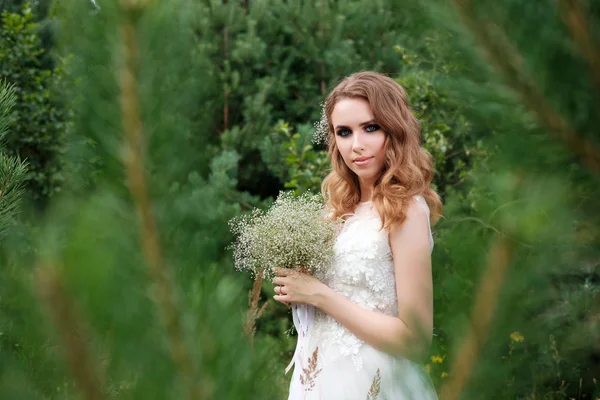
left=119, top=0, right=204, bottom=400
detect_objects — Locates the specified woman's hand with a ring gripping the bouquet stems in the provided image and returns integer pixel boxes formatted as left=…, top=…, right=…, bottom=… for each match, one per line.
left=273, top=268, right=329, bottom=306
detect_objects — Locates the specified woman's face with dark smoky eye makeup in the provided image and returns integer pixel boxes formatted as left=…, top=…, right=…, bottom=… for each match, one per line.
left=331, top=98, right=387, bottom=185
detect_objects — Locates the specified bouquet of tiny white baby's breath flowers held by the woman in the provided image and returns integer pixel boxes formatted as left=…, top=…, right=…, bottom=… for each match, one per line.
left=230, top=192, right=335, bottom=279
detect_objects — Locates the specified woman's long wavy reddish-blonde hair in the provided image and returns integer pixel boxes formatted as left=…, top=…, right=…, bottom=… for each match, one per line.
left=321, top=71, right=442, bottom=230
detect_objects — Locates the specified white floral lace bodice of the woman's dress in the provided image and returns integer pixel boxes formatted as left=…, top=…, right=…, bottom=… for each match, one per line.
left=311, top=197, right=433, bottom=370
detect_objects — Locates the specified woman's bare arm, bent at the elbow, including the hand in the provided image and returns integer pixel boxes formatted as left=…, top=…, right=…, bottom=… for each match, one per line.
left=273, top=202, right=433, bottom=362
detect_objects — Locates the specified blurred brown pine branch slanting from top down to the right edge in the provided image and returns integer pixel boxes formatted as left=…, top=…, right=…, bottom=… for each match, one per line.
left=451, top=0, right=600, bottom=175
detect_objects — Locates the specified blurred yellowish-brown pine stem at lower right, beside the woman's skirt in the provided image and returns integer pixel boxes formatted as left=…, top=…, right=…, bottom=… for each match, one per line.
left=440, top=236, right=513, bottom=400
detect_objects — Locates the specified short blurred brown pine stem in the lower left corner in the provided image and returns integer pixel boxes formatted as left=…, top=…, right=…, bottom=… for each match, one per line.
left=36, top=265, right=105, bottom=400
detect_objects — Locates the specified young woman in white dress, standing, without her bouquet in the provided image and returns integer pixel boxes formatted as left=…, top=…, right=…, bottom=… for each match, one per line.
left=273, top=72, right=441, bottom=400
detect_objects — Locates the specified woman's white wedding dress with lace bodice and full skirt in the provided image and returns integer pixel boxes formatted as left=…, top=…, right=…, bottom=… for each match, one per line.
left=288, top=196, right=437, bottom=400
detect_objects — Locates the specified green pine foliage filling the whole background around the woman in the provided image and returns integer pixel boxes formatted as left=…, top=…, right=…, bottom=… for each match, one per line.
left=0, top=0, right=600, bottom=399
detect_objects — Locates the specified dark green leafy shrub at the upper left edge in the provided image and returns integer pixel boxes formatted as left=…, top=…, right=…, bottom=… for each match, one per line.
left=0, top=6, right=68, bottom=204
